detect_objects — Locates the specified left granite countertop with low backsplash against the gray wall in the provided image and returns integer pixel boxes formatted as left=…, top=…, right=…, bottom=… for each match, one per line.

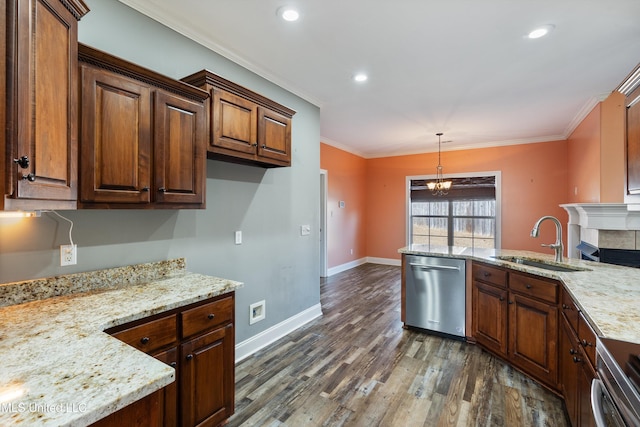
left=0, top=259, right=242, bottom=426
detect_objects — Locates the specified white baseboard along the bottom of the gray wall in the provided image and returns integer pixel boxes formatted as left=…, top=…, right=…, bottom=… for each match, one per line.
left=236, top=303, right=322, bottom=363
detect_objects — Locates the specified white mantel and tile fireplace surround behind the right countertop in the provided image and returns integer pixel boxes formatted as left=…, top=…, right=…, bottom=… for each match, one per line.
left=560, top=203, right=640, bottom=258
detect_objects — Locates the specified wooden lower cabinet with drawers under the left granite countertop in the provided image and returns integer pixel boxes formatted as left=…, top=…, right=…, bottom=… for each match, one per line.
left=105, top=292, right=235, bottom=427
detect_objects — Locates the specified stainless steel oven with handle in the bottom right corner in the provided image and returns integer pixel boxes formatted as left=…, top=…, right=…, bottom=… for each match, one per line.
left=591, top=337, right=640, bottom=427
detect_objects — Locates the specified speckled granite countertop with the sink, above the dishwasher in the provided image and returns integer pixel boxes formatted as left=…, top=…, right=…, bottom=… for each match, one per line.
left=398, top=244, right=640, bottom=343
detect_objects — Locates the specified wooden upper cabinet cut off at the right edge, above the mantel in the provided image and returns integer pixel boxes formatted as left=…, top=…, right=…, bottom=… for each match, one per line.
left=618, top=64, right=640, bottom=203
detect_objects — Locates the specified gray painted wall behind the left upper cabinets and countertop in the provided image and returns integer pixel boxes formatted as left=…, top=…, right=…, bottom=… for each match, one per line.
left=0, top=0, right=320, bottom=342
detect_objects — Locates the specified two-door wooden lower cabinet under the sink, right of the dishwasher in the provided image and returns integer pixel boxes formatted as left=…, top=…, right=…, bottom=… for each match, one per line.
left=472, top=262, right=559, bottom=390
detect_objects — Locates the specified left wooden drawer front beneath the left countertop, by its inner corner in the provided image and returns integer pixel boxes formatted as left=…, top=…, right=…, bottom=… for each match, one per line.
left=112, top=314, right=178, bottom=353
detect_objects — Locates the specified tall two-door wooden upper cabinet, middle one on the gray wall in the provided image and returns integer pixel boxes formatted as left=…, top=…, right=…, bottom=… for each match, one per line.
left=79, top=45, right=208, bottom=208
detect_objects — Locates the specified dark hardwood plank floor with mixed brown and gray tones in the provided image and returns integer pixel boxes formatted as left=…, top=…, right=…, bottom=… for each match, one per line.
left=229, top=264, right=567, bottom=427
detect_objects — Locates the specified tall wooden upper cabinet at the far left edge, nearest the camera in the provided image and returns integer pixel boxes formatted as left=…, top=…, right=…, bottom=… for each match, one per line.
left=0, top=0, right=89, bottom=210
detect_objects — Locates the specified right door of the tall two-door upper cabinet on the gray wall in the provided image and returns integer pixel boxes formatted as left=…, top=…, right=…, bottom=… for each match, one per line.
left=154, top=90, right=207, bottom=204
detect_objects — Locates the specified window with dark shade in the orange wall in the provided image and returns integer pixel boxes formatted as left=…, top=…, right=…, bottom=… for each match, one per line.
left=409, top=175, right=499, bottom=249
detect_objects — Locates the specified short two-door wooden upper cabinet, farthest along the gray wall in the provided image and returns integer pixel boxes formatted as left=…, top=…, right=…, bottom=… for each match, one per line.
left=182, top=70, right=295, bottom=167
